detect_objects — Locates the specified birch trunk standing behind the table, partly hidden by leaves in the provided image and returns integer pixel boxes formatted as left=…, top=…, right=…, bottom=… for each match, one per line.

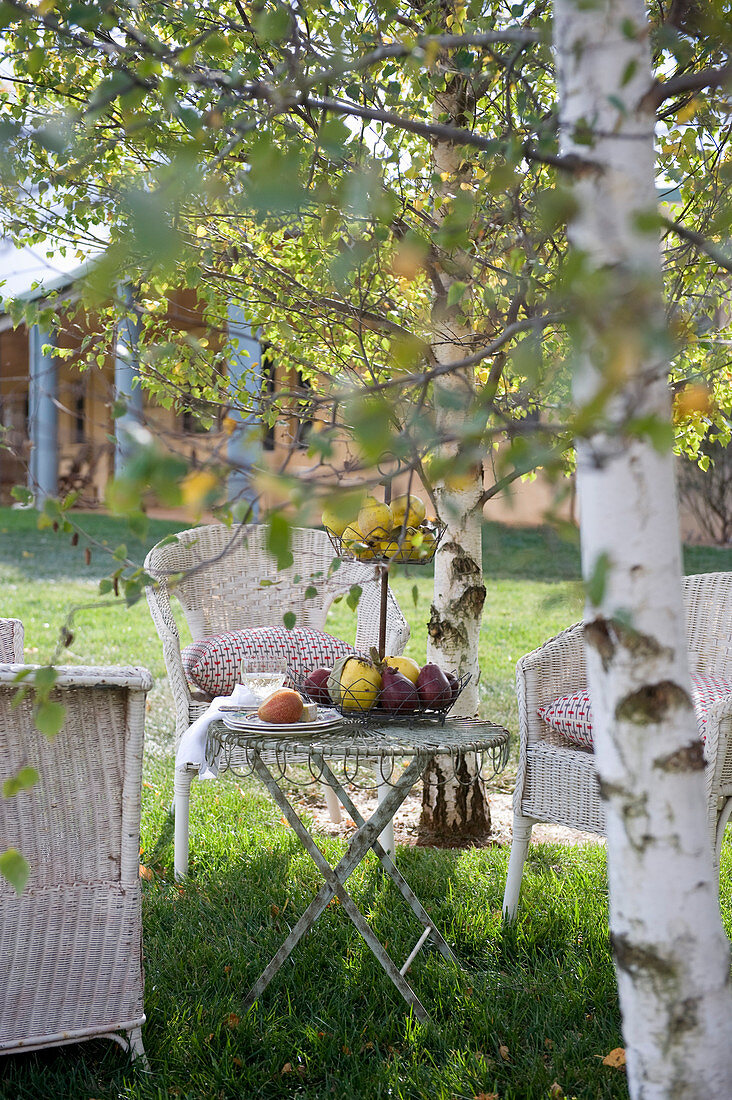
left=417, top=64, right=491, bottom=846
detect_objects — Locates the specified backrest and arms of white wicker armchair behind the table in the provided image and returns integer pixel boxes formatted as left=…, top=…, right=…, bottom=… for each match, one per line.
left=144, top=524, right=409, bottom=746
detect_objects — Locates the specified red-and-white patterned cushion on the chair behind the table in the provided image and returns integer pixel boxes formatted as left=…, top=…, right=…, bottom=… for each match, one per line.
left=181, top=626, right=356, bottom=696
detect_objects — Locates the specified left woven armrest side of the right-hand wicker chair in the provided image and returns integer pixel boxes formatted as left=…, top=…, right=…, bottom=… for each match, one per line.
left=516, top=623, right=587, bottom=751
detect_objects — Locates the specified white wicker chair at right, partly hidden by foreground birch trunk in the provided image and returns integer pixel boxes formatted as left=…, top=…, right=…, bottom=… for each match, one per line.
left=503, top=573, right=732, bottom=917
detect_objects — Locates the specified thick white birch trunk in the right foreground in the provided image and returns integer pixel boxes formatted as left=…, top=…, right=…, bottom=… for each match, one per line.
left=554, top=0, right=732, bottom=1100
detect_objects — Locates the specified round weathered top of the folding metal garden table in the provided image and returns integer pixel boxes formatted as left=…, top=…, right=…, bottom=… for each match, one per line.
left=209, top=717, right=510, bottom=759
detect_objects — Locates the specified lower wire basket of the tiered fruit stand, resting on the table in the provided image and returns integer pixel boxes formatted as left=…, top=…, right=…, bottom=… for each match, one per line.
left=291, top=672, right=470, bottom=725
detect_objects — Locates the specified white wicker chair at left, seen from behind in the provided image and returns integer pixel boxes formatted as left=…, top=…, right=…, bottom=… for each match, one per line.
left=0, top=664, right=152, bottom=1059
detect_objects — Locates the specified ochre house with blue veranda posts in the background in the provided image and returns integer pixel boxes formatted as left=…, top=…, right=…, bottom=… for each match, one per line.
left=0, top=241, right=717, bottom=540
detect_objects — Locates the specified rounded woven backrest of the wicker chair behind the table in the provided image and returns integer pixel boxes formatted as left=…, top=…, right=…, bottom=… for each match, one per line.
left=145, top=524, right=391, bottom=639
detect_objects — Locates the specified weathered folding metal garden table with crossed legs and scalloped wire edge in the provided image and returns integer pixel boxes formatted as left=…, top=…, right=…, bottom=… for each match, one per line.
left=176, top=718, right=509, bottom=1020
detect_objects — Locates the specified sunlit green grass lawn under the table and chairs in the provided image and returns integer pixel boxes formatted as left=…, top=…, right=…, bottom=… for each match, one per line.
left=0, top=509, right=732, bottom=1100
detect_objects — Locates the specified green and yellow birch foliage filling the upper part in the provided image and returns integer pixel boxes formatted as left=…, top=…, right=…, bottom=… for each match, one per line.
left=0, top=0, right=730, bottom=519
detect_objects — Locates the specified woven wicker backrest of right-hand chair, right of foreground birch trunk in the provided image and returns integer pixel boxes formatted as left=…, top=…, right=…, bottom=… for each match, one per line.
left=684, top=573, right=732, bottom=679
